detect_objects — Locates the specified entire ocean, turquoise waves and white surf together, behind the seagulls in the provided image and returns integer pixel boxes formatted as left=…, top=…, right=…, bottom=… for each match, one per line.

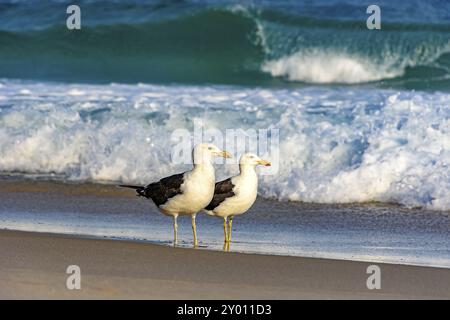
left=0, top=0, right=450, bottom=211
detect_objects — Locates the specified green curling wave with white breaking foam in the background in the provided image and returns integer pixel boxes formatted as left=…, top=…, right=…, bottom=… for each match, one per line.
left=0, top=6, right=450, bottom=90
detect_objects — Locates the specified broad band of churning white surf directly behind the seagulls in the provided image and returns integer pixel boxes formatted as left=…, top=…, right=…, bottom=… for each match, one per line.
left=0, top=81, right=450, bottom=210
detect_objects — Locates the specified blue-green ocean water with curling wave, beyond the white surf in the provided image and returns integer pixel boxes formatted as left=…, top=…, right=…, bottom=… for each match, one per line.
left=0, top=0, right=450, bottom=90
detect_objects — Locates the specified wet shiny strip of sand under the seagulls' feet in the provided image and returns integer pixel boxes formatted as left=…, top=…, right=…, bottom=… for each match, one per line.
left=0, top=179, right=450, bottom=268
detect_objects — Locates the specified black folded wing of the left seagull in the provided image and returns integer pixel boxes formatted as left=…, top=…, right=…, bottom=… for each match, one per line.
left=138, top=173, right=184, bottom=206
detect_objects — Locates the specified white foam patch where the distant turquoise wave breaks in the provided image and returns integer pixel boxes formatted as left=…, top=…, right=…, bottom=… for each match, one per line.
left=262, top=50, right=404, bottom=84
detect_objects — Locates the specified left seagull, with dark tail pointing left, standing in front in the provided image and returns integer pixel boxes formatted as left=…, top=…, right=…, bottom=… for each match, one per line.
left=120, top=143, right=231, bottom=246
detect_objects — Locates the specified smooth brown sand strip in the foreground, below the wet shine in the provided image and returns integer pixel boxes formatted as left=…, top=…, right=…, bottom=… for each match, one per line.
left=0, top=230, right=450, bottom=299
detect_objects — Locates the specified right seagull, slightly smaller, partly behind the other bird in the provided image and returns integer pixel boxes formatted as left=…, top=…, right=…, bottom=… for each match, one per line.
left=204, top=153, right=271, bottom=245
